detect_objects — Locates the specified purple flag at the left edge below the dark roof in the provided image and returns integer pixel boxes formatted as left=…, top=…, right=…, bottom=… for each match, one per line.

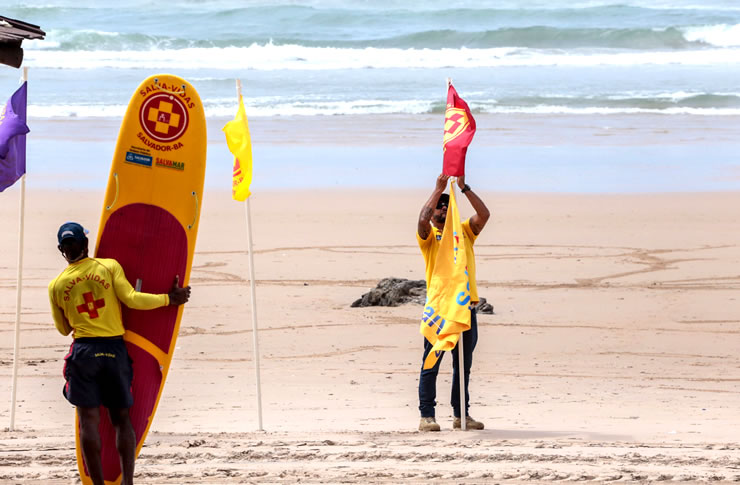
left=0, top=82, right=30, bottom=192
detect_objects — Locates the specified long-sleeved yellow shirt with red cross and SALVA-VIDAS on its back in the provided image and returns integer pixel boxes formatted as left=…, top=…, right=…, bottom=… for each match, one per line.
left=49, top=258, right=170, bottom=338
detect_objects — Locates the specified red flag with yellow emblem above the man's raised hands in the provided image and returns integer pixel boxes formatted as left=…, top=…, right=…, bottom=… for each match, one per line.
left=442, top=79, right=475, bottom=177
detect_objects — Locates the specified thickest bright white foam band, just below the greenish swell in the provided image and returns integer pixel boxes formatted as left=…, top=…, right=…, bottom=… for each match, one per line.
left=24, top=43, right=740, bottom=71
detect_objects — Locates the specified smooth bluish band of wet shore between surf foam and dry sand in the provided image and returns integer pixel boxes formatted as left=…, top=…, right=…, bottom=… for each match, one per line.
left=14, top=110, right=740, bottom=194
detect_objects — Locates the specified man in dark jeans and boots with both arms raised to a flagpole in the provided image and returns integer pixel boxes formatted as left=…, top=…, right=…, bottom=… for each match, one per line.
left=416, top=174, right=490, bottom=431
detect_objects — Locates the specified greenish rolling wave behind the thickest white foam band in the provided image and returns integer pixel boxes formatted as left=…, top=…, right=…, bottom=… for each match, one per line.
left=24, top=24, right=740, bottom=52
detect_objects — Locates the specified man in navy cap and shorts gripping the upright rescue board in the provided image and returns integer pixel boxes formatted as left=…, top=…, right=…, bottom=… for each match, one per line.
left=49, top=222, right=190, bottom=485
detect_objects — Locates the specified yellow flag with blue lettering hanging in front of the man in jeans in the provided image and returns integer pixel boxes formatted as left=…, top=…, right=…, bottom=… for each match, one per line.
left=420, top=181, right=470, bottom=369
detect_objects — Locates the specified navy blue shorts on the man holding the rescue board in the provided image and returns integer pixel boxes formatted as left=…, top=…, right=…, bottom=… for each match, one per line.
left=62, top=337, right=134, bottom=408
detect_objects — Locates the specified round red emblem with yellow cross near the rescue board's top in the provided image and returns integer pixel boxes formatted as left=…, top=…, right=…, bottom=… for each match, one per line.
left=139, top=93, right=188, bottom=142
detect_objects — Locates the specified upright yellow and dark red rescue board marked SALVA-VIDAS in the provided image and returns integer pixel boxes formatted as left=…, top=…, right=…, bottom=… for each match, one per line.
left=76, top=74, right=206, bottom=485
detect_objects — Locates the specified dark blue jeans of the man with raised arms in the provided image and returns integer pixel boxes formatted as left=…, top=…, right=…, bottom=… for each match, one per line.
left=419, top=309, right=478, bottom=418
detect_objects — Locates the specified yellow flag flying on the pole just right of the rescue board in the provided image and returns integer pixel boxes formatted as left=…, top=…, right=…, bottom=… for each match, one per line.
left=223, top=95, right=252, bottom=201
